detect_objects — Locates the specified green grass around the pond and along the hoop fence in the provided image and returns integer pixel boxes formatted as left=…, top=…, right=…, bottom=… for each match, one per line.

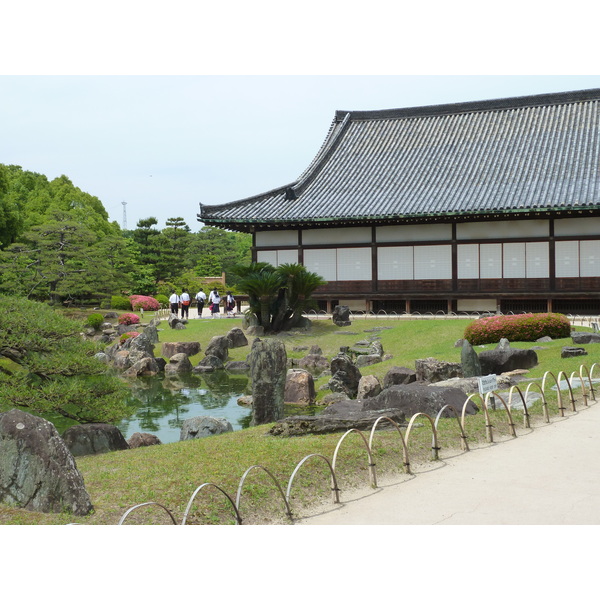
left=0, top=315, right=600, bottom=525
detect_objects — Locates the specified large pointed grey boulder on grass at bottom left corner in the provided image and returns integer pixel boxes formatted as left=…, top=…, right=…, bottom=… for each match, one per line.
left=0, top=409, right=93, bottom=516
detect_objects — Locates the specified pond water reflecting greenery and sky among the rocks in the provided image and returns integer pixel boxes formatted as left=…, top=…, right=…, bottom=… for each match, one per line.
left=119, top=372, right=252, bottom=444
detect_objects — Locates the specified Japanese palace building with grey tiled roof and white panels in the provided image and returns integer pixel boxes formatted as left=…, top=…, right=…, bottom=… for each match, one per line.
left=198, top=89, right=600, bottom=314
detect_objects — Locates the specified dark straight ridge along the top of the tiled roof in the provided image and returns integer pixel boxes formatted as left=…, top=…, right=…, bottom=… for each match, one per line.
left=335, top=88, right=600, bottom=121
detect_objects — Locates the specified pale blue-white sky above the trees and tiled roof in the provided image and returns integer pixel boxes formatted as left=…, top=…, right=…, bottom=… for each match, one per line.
left=0, top=75, right=600, bottom=231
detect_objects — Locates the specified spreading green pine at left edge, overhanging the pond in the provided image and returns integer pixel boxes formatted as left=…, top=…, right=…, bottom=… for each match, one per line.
left=0, top=296, right=129, bottom=422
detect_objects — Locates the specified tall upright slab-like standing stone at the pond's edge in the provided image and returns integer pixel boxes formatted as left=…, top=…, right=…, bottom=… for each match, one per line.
left=247, top=338, right=287, bottom=425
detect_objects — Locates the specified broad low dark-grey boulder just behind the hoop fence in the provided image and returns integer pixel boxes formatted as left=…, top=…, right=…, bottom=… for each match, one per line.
left=363, top=383, right=478, bottom=419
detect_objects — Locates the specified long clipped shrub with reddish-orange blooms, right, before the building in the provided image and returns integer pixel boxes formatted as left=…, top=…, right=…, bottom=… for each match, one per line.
left=464, top=313, right=571, bottom=346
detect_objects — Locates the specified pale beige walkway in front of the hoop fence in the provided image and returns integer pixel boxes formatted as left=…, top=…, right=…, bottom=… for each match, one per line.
left=297, top=401, right=600, bottom=525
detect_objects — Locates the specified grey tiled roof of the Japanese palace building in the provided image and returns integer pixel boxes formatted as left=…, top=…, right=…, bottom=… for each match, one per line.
left=198, top=89, right=600, bottom=229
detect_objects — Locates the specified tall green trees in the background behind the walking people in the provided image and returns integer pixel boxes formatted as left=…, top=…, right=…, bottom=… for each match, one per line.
left=0, top=165, right=252, bottom=310
